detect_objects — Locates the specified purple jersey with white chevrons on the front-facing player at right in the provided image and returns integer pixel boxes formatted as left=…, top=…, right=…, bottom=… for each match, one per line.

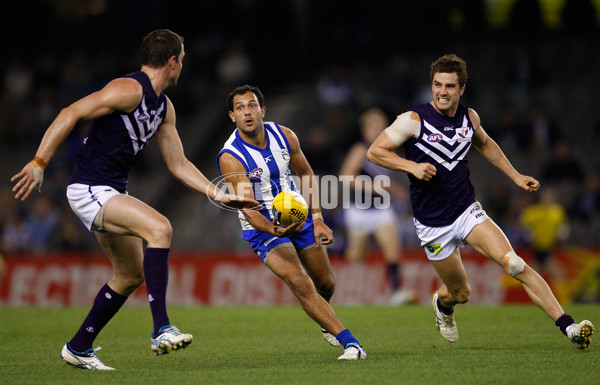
left=405, top=103, right=475, bottom=227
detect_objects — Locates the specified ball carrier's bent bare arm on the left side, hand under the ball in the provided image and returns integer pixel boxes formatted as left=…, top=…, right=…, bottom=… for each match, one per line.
left=219, top=153, right=304, bottom=237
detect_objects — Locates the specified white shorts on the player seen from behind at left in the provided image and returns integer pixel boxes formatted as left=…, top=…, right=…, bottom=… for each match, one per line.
left=67, top=183, right=120, bottom=231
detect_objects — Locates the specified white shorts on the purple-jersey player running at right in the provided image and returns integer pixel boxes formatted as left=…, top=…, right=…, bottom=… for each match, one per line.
left=413, top=202, right=490, bottom=261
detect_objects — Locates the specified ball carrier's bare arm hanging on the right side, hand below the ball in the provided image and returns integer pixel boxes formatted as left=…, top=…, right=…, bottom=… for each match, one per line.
left=281, top=126, right=333, bottom=245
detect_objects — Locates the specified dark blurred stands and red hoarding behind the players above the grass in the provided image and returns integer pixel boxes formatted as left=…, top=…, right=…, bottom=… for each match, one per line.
left=0, top=0, right=600, bottom=305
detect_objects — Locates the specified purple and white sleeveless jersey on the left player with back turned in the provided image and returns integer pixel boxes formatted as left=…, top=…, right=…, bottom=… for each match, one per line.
left=69, top=71, right=167, bottom=193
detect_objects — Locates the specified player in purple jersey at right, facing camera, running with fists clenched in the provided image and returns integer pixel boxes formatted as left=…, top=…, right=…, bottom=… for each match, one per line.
left=368, top=54, right=594, bottom=349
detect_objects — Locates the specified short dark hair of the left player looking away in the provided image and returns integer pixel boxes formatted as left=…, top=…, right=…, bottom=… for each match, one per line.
left=142, top=29, right=183, bottom=68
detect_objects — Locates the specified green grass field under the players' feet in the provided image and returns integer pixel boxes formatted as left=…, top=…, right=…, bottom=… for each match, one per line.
left=0, top=305, right=600, bottom=385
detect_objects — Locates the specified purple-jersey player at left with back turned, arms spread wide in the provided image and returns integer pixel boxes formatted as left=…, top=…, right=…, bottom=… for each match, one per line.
left=11, top=29, right=258, bottom=370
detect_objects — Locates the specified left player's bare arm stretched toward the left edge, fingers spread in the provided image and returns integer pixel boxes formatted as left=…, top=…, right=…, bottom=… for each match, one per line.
left=10, top=78, right=143, bottom=200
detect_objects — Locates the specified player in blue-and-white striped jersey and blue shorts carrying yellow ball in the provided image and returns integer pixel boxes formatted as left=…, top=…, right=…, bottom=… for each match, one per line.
left=217, top=86, right=367, bottom=360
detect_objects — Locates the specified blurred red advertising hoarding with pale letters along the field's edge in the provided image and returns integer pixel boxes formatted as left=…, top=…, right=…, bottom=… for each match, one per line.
left=0, top=248, right=600, bottom=306
